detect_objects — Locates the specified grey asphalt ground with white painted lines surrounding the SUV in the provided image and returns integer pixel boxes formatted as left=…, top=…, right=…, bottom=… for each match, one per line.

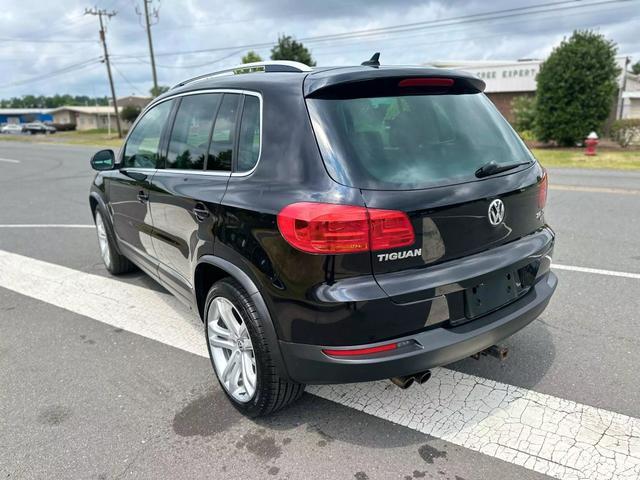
left=0, top=142, right=640, bottom=480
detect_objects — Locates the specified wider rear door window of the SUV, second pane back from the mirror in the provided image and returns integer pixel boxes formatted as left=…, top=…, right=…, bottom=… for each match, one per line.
left=165, top=94, right=222, bottom=170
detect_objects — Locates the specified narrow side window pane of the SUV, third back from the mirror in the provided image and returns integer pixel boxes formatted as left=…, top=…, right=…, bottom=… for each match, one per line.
left=207, top=93, right=241, bottom=171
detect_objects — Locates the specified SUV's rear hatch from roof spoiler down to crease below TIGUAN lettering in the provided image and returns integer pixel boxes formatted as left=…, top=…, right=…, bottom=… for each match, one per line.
left=306, top=69, right=546, bottom=286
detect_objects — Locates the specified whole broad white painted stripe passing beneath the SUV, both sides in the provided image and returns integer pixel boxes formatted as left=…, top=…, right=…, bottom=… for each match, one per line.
left=0, top=250, right=640, bottom=480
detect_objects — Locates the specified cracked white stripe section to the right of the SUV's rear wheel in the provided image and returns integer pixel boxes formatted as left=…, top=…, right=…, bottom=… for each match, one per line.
left=309, top=368, right=640, bottom=480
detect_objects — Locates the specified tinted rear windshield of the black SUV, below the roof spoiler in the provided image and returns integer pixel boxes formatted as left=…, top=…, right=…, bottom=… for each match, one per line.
left=307, top=93, right=533, bottom=190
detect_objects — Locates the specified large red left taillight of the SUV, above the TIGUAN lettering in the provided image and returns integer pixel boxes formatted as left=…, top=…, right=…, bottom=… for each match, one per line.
left=278, top=202, right=415, bottom=254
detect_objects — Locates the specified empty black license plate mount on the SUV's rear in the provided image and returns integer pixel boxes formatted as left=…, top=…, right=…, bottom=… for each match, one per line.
left=464, top=271, right=519, bottom=319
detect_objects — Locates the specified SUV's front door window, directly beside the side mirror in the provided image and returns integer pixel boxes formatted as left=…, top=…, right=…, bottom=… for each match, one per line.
left=122, top=100, right=173, bottom=168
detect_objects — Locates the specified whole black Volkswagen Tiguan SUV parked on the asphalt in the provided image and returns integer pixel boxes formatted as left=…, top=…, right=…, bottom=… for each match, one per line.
left=90, top=62, right=557, bottom=415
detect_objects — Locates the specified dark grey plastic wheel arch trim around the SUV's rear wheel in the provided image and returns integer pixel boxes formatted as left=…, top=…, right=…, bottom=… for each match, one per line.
left=193, top=255, right=290, bottom=379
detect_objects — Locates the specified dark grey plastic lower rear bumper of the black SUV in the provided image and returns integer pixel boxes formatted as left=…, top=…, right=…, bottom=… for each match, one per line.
left=280, top=272, right=558, bottom=384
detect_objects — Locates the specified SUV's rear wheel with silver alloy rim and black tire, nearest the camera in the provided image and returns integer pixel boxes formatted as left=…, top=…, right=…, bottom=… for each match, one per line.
left=204, top=278, right=305, bottom=417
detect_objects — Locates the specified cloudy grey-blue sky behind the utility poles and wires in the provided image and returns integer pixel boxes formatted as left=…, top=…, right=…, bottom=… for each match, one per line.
left=0, top=0, right=640, bottom=98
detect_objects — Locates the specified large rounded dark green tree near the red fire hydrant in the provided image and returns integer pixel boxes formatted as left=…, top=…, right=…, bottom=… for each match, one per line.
left=536, top=31, right=620, bottom=146
